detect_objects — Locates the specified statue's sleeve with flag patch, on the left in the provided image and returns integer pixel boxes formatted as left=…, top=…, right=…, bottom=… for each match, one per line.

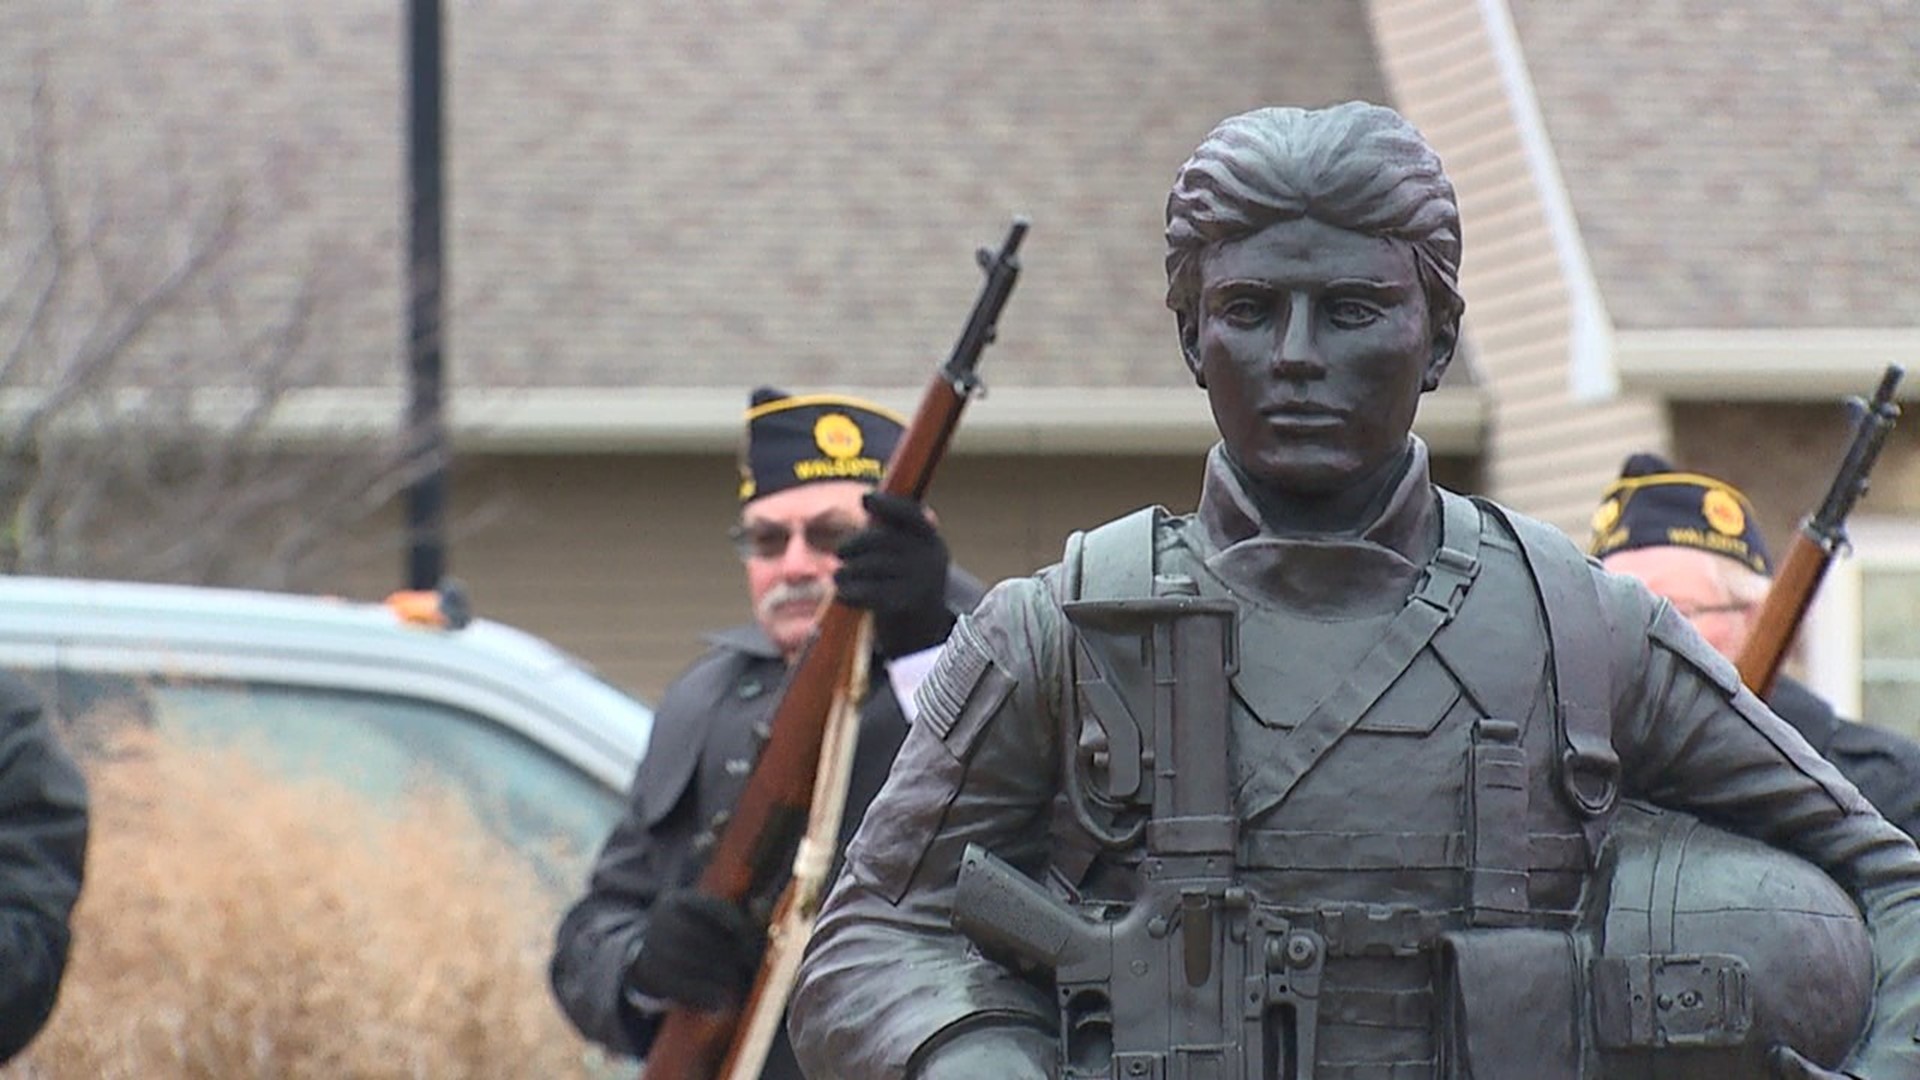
left=789, top=578, right=1062, bottom=1080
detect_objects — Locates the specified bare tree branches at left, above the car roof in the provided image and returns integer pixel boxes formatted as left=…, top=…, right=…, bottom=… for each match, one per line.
left=0, top=73, right=422, bottom=588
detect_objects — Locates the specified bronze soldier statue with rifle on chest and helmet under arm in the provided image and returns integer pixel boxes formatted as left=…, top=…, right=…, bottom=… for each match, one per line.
left=789, top=102, right=1920, bottom=1080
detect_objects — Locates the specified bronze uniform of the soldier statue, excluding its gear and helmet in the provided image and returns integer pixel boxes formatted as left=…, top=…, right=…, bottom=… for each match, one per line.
left=791, top=442, right=1920, bottom=1080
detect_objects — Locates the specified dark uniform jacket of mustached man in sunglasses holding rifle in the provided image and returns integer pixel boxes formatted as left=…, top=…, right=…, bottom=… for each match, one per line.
left=551, top=573, right=981, bottom=1080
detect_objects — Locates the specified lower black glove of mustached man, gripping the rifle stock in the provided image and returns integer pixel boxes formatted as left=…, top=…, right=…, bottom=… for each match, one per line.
left=626, top=890, right=766, bottom=1013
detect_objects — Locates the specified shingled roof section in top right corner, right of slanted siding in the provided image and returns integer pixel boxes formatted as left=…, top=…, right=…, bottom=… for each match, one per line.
left=1509, top=0, right=1920, bottom=331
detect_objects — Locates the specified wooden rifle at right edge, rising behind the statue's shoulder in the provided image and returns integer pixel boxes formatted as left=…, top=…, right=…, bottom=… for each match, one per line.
left=1738, top=363, right=1905, bottom=698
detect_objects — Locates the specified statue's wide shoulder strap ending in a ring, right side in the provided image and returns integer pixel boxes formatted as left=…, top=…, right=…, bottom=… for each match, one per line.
left=1475, top=498, right=1620, bottom=824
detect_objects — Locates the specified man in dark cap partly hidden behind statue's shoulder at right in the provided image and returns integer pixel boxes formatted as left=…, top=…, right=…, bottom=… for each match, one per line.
left=1588, top=454, right=1920, bottom=836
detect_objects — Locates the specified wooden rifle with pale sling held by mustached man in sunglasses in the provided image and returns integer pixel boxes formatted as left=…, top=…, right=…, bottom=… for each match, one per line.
left=641, top=217, right=1027, bottom=1080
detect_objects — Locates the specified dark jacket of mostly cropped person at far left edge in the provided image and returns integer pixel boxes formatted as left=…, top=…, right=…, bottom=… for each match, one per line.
left=0, top=673, right=86, bottom=1061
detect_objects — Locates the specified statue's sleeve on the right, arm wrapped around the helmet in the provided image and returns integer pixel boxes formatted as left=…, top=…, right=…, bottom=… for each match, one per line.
left=1603, top=578, right=1920, bottom=1080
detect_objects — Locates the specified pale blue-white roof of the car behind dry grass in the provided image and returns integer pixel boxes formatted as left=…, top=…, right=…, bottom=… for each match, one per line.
left=0, top=577, right=653, bottom=790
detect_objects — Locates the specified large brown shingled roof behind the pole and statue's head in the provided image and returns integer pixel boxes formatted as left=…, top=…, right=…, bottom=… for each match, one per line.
left=0, top=0, right=1413, bottom=392
